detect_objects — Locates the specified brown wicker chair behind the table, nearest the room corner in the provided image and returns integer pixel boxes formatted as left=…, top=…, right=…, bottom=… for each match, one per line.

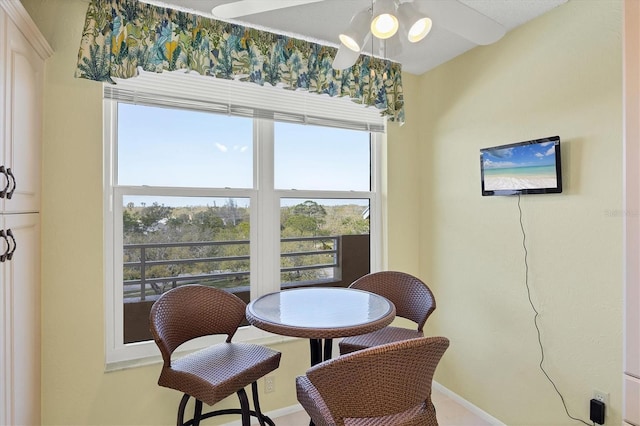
left=339, top=271, right=436, bottom=355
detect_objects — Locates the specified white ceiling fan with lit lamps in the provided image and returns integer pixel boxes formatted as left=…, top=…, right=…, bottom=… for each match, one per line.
left=212, top=0, right=506, bottom=69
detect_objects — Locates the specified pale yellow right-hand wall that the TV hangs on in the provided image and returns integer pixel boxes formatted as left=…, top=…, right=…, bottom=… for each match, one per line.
left=419, top=0, right=622, bottom=425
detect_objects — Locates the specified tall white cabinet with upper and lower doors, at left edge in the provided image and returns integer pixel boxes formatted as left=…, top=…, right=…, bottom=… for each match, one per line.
left=0, top=0, right=52, bottom=425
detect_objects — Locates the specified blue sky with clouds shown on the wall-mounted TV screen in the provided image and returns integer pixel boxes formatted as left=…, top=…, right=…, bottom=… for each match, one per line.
left=482, top=142, right=556, bottom=169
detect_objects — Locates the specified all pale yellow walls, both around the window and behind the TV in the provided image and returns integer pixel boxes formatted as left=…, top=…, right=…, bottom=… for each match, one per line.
left=23, top=0, right=622, bottom=425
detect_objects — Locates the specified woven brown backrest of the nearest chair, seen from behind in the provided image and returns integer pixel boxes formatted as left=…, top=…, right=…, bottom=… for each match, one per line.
left=307, top=337, right=449, bottom=424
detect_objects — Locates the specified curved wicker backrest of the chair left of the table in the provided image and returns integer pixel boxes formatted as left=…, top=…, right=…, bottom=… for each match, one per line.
left=149, top=285, right=246, bottom=366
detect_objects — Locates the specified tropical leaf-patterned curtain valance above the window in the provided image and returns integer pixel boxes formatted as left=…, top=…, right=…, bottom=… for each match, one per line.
left=76, top=0, right=404, bottom=124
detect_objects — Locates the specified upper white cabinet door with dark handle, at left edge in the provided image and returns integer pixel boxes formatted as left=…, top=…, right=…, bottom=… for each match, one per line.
left=0, top=15, right=44, bottom=212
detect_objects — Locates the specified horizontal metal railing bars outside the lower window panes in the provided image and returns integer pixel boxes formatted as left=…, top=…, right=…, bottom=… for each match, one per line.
left=123, top=236, right=340, bottom=302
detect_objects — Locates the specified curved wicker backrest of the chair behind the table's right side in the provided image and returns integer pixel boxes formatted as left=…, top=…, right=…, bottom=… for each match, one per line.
left=349, top=271, right=436, bottom=331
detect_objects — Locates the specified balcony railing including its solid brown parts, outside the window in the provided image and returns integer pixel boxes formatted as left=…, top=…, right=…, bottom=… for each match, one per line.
left=123, top=234, right=370, bottom=343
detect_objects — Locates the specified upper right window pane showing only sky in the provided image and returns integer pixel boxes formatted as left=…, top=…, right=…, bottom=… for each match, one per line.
left=274, top=122, right=371, bottom=191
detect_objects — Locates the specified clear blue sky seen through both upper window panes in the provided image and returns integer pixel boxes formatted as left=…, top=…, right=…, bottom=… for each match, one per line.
left=118, top=103, right=370, bottom=206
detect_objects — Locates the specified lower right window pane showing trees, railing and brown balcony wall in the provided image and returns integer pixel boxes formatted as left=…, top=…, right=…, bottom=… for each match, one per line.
left=280, top=198, right=370, bottom=287
